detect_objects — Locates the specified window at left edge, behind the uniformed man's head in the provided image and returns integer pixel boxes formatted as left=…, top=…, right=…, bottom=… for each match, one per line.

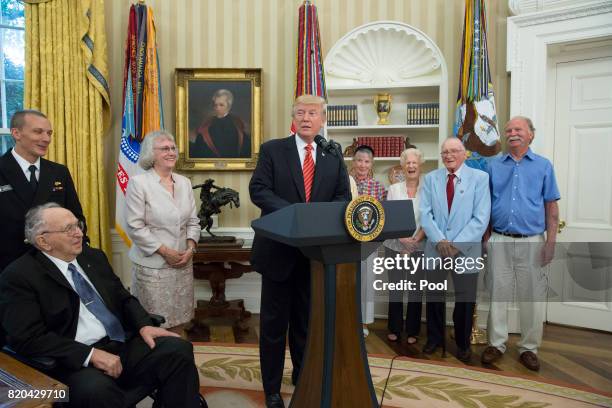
left=0, top=0, right=25, bottom=154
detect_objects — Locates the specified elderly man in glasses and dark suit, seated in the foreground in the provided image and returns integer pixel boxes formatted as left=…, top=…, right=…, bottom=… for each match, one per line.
left=0, top=203, right=206, bottom=408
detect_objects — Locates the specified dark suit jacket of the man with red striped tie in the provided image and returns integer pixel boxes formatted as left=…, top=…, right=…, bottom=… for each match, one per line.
left=249, top=135, right=351, bottom=281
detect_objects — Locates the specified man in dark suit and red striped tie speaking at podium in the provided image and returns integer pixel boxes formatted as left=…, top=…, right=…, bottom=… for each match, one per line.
left=249, top=95, right=350, bottom=407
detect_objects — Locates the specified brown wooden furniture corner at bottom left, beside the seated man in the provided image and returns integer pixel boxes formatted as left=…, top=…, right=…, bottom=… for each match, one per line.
left=0, top=352, right=68, bottom=408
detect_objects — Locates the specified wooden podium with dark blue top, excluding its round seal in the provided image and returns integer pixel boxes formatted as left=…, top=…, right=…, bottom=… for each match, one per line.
left=252, top=200, right=415, bottom=408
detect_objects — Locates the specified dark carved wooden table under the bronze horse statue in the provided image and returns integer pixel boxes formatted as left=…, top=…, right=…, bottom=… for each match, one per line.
left=193, top=239, right=253, bottom=331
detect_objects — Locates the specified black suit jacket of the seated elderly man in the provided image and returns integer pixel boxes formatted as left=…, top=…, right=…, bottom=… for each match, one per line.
left=0, top=246, right=151, bottom=370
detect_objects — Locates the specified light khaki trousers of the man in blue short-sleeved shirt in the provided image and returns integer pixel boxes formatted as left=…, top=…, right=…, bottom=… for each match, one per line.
left=487, top=232, right=548, bottom=353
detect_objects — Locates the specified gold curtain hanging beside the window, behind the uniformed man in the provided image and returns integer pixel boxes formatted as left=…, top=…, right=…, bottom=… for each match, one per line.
left=24, top=0, right=111, bottom=257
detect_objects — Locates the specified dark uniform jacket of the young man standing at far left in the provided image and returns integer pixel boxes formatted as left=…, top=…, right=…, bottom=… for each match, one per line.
left=0, top=151, right=85, bottom=272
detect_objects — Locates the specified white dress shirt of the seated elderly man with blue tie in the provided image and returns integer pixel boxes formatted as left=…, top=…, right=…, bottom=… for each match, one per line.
left=43, top=252, right=106, bottom=367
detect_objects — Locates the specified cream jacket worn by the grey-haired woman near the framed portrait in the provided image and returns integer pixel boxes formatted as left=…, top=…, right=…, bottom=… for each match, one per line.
left=125, top=169, right=200, bottom=268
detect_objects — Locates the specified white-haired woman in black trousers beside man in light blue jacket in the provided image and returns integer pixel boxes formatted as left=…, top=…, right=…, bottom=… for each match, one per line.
left=384, top=149, right=425, bottom=344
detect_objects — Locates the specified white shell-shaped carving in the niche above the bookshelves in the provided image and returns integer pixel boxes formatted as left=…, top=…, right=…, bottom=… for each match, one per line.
left=325, top=22, right=441, bottom=86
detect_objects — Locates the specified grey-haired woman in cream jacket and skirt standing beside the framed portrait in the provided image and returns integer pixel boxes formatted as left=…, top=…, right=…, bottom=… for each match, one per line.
left=126, top=131, right=200, bottom=327
